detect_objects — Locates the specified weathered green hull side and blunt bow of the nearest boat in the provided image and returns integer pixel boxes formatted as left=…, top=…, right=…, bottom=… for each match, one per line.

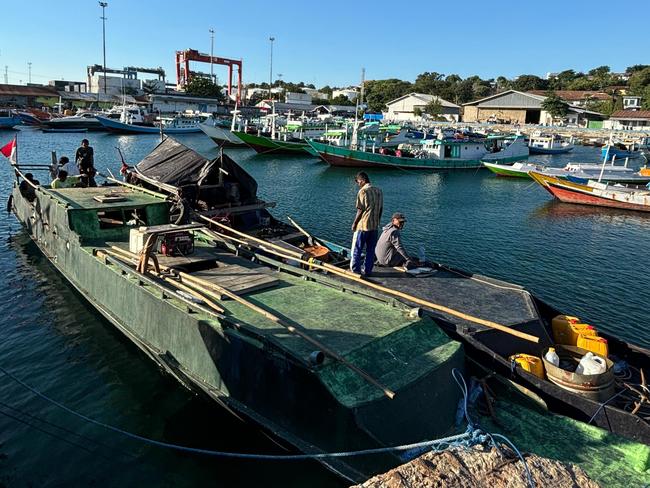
left=12, top=185, right=464, bottom=482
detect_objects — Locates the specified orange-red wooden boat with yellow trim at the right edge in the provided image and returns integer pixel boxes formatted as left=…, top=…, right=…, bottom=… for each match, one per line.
left=530, top=171, right=650, bottom=212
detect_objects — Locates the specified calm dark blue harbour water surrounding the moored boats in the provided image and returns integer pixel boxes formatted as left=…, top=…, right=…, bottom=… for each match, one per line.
left=0, top=130, right=650, bottom=486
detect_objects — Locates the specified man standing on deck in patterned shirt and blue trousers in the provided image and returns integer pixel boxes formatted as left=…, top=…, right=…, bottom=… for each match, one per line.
left=350, top=171, right=384, bottom=276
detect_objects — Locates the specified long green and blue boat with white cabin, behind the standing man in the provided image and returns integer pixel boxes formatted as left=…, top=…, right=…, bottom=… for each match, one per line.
left=308, top=137, right=528, bottom=170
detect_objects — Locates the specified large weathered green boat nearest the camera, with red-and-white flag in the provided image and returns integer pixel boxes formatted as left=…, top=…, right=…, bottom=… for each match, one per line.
left=10, top=153, right=464, bottom=481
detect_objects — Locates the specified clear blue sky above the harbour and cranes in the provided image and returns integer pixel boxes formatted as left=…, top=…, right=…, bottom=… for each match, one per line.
left=0, top=0, right=650, bottom=86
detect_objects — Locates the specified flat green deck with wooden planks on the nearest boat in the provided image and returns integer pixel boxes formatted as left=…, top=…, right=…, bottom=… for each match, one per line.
left=104, top=242, right=440, bottom=361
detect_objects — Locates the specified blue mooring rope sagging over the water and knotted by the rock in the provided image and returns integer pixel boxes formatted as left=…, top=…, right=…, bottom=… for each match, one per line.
left=0, top=366, right=535, bottom=488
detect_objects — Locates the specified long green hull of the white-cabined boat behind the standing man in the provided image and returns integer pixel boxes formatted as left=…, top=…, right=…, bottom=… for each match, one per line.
left=309, top=141, right=521, bottom=170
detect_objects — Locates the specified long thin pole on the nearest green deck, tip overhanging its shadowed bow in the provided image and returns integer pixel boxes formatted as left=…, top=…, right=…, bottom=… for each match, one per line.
left=106, top=246, right=395, bottom=400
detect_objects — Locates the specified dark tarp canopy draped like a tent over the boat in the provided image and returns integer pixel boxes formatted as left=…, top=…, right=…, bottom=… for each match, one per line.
left=136, top=137, right=257, bottom=204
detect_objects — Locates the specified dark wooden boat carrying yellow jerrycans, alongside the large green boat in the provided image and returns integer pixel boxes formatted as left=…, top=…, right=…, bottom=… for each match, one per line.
left=133, top=138, right=650, bottom=443
